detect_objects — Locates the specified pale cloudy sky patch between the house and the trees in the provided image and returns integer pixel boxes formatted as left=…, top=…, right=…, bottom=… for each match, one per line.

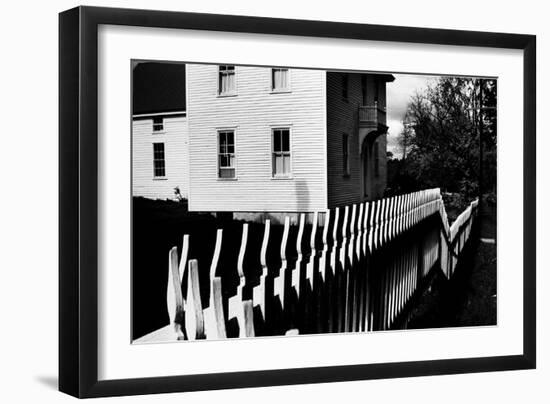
left=386, top=74, right=437, bottom=157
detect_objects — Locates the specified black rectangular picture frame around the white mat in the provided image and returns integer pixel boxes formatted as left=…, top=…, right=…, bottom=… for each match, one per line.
left=59, top=7, right=536, bottom=397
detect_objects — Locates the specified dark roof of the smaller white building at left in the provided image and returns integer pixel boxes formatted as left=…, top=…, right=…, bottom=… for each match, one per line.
left=132, top=62, right=186, bottom=115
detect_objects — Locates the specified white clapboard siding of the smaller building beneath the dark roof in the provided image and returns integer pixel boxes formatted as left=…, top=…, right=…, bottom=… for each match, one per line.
left=132, top=116, right=189, bottom=199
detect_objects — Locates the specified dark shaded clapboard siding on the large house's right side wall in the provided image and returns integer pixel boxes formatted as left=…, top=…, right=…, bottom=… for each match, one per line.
left=327, top=72, right=386, bottom=208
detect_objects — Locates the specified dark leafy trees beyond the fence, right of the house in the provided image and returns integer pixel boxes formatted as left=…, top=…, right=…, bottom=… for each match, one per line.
left=388, top=77, right=496, bottom=199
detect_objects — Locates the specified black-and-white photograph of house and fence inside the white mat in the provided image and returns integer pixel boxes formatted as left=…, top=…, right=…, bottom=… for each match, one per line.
left=130, top=60, right=498, bottom=344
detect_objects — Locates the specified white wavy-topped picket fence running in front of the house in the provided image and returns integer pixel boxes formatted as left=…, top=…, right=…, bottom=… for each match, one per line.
left=135, top=189, right=478, bottom=343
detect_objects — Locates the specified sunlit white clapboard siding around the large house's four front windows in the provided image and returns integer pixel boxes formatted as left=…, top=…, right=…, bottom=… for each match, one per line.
left=187, top=64, right=327, bottom=212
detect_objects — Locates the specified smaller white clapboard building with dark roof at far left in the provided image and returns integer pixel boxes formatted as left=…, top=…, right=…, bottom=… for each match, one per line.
left=132, top=63, right=189, bottom=199
